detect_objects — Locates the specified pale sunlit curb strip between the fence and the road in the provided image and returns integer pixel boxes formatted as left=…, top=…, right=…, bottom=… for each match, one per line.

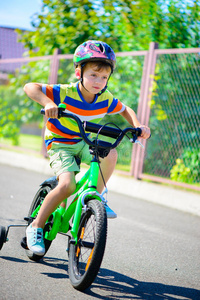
left=0, top=149, right=200, bottom=216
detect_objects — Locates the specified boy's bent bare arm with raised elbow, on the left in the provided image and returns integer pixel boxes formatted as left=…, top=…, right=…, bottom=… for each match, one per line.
left=24, top=82, right=58, bottom=118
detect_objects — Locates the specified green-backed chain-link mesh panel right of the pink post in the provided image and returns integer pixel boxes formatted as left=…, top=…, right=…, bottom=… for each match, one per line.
left=143, top=53, right=200, bottom=184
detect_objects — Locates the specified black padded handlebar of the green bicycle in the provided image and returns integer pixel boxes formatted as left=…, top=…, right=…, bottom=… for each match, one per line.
left=41, top=109, right=142, bottom=149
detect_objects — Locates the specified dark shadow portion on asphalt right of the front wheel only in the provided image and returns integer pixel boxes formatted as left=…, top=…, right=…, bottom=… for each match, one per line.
left=85, top=269, right=200, bottom=300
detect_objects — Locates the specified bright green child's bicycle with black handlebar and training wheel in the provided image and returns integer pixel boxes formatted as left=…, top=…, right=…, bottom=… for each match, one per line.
left=0, top=105, right=141, bottom=291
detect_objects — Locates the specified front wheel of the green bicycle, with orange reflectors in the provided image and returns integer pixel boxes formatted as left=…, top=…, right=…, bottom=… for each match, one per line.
left=69, top=199, right=107, bottom=291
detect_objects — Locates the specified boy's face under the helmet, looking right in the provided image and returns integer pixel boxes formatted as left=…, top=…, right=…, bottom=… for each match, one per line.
left=83, top=63, right=111, bottom=95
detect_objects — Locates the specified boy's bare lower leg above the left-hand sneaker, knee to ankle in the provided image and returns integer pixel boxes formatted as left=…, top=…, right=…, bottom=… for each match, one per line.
left=32, top=172, right=76, bottom=228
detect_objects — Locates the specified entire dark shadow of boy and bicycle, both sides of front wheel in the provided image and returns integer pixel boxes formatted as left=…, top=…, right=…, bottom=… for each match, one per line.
left=1, top=256, right=200, bottom=300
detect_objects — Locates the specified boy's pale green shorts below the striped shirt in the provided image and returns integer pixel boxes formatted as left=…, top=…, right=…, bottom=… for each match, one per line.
left=47, top=141, right=92, bottom=176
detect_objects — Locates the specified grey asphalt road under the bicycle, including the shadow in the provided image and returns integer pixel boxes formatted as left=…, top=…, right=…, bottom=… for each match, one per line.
left=0, top=165, right=200, bottom=300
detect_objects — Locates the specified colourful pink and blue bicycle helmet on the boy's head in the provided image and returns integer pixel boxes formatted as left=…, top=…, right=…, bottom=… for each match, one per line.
left=73, top=40, right=116, bottom=72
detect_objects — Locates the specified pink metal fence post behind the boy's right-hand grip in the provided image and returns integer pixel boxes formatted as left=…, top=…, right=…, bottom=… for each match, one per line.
left=131, top=42, right=158, bottom=179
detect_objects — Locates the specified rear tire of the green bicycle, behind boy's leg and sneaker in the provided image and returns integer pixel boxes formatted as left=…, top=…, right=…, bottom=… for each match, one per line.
left=25, top=185, right=52, bottom=261
